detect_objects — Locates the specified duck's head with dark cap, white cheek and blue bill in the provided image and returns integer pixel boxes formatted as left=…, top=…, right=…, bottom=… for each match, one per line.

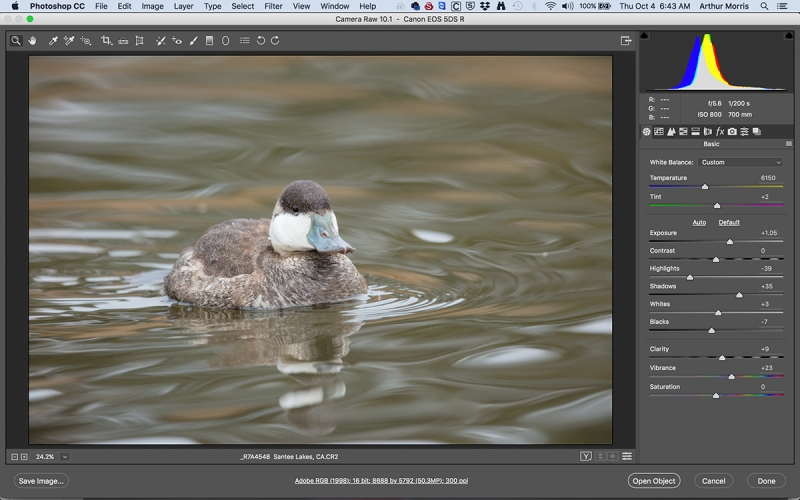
left=269, top=181, right=356, bottom=255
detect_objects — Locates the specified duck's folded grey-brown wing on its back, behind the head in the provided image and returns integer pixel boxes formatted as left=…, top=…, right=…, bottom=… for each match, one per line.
left=192, top=219, right=272, bottom=278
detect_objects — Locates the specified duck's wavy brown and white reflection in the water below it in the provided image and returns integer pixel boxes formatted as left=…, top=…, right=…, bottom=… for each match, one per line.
left=170, top=304, right=364, bottom=435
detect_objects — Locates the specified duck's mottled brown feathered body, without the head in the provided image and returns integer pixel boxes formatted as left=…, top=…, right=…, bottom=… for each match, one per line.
left=164, top=219, right=367, bottom=309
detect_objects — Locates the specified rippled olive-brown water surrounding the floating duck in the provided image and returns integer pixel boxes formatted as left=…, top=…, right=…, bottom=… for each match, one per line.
left=29, top=57, right=611, bottom=444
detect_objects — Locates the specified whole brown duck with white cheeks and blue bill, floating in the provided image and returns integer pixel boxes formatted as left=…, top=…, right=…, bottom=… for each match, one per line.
left=164, top=180, right=367, bottom=310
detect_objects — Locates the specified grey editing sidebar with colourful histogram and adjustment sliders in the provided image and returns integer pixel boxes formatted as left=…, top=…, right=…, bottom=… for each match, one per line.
left=637, top=31, right=797, bottom=472
